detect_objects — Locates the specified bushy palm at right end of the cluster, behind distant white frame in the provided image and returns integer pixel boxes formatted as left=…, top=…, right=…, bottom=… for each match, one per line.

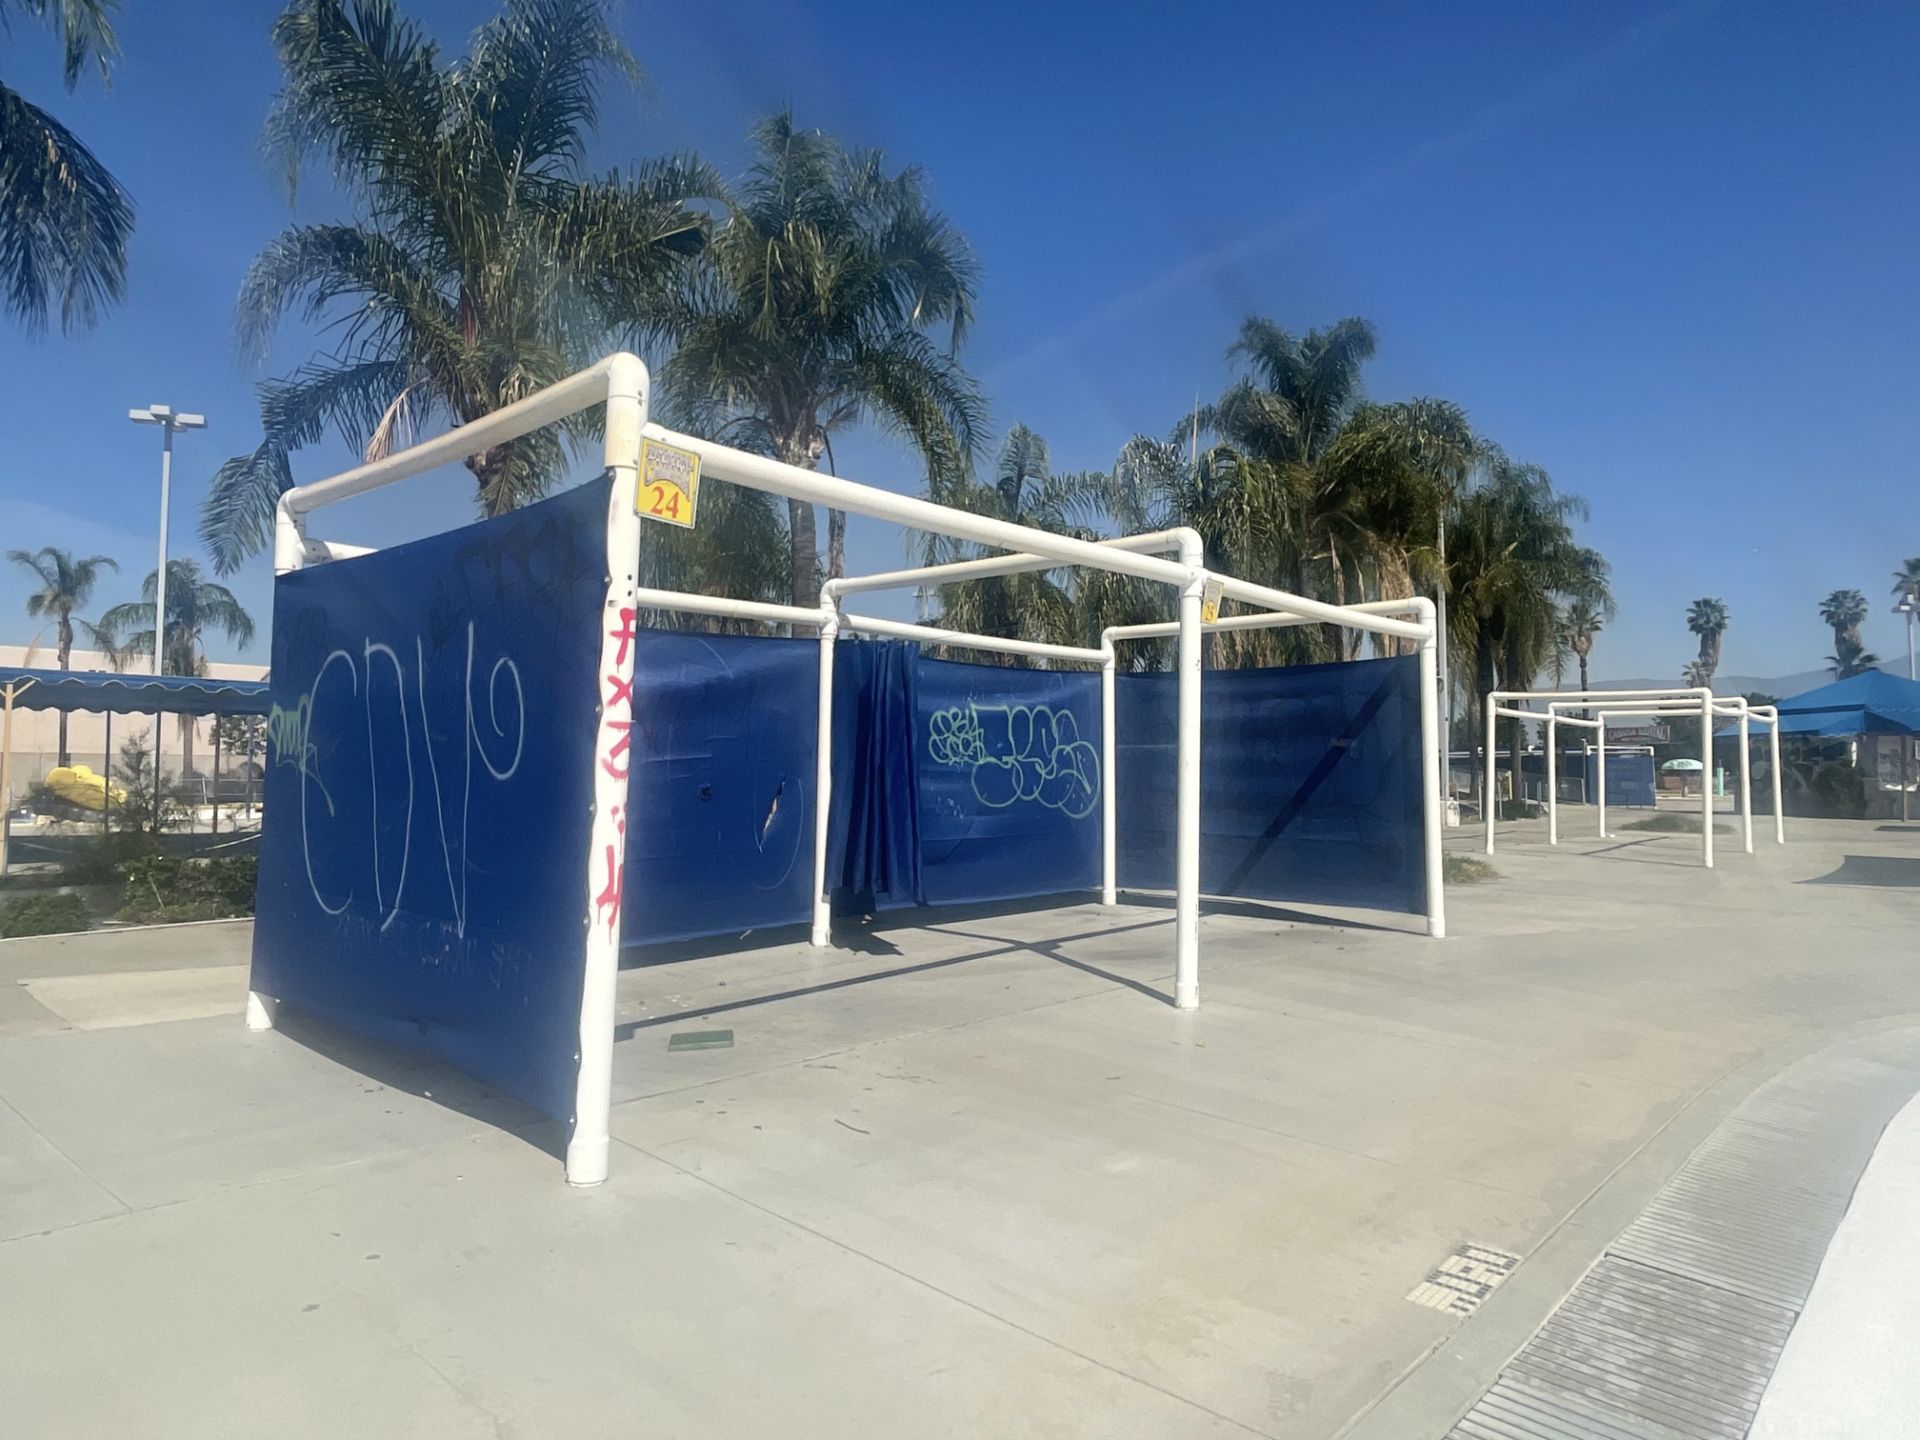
left=1448, top=456, right=1613, bottom=794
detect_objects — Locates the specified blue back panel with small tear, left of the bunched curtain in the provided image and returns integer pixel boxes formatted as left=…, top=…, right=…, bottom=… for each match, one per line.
left=622, top=630, right=820, bottom=945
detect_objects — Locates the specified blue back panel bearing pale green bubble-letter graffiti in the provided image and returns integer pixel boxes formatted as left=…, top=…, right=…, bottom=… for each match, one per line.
left=914, top=659, right=1100, bottom=904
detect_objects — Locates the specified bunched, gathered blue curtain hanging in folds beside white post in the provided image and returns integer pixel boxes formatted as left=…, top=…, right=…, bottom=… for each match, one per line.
left=828, top=639, right=925, bottom=914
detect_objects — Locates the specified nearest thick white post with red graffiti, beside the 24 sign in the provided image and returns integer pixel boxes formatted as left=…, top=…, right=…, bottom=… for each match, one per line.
left=566, top=355, right=647, bottom=1185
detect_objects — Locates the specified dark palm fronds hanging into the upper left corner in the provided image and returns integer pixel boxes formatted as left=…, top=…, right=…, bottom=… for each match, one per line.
left=0, top=0, right=132, bottom=332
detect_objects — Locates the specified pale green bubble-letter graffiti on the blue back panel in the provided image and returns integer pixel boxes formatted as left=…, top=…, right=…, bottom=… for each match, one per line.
left=927, top=701, right=1100, bottom=820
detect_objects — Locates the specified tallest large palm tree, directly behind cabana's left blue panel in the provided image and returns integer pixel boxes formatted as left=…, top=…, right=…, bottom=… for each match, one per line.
left=200, top=0, right=718, bottom=572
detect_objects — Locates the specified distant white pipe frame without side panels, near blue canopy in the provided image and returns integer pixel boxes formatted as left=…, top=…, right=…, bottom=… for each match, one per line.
left=1482, top=685, right=1788, bottom=870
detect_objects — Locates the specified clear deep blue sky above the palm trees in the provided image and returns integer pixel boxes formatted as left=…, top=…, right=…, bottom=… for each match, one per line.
left=0, top=0, right=1920, bottom=678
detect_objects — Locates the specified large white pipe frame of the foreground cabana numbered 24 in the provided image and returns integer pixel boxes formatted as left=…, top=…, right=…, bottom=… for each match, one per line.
left=246, top=353, right=1444, bottom=1185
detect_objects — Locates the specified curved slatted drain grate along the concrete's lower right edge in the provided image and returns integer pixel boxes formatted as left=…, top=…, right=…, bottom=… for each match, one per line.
left=1450, top=1033, right=1920, bottom=1440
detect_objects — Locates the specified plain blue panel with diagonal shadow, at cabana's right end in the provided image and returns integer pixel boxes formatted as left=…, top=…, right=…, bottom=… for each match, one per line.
left=1114, top=657, right=1427, bottom=914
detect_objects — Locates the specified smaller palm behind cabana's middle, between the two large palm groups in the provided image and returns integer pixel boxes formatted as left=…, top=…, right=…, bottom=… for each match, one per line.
left=924, top=424, right=1106, bottom=645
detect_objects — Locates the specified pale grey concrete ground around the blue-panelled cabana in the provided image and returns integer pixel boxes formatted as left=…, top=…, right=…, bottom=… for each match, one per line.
left=0, top=816, right=1920, bottom=1440
